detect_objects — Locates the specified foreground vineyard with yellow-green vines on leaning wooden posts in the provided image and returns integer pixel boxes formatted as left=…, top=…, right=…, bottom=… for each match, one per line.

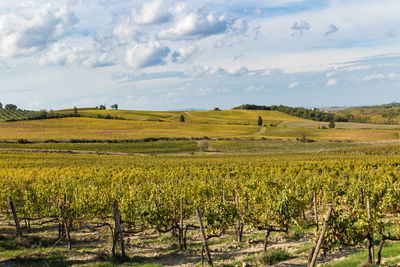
left=0, top=152, right=400, bottom=266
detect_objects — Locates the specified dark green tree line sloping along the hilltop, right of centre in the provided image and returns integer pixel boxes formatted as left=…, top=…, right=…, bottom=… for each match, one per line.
left=233, top=104, right=349, bottom=122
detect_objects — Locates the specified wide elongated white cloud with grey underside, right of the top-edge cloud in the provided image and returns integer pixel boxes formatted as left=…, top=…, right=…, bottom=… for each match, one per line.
left=158, top=12, right=232, bottom=40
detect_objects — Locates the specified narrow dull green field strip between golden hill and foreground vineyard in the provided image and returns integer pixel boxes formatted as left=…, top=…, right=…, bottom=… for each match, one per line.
left=0, top=139, right=400, bottom=155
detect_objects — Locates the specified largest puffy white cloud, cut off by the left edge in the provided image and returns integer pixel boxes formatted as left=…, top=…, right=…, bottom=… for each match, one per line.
left=0, top=4, right=78, bottom=57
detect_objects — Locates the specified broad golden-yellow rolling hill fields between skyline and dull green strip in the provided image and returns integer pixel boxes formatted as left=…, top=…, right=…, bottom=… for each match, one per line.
left=0, top=109, right=400, bottom=141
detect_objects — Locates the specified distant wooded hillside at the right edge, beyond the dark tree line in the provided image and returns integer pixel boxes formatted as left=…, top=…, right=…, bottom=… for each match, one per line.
left=336, top=102, right=400, bottom=124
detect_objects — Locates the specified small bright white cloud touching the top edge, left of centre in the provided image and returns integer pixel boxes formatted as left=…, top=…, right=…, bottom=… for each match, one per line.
left=132, top=0, right=172, bottom=24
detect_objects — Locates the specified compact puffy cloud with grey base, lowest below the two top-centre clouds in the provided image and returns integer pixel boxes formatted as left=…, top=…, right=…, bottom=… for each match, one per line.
left=126, top=42, right=170, bottom=68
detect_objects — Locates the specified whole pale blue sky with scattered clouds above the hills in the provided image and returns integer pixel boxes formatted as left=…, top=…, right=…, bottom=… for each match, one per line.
left=0, top=0, right=400, bottom=110
